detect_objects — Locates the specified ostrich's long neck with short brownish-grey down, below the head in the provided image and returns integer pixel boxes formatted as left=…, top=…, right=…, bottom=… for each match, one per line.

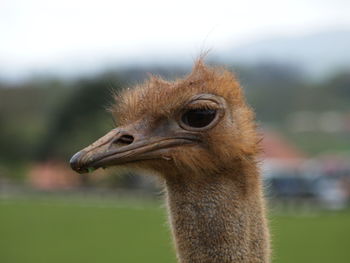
left=166, top=168, right=269, bottom=263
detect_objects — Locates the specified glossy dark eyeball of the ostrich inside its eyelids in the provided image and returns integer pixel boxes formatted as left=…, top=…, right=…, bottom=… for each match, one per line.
left=182, top=109, right=216, bottom=128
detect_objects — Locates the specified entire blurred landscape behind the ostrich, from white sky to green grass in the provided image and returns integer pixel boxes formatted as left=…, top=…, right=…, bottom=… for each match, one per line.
left=0, top=0, right=350, bottom=263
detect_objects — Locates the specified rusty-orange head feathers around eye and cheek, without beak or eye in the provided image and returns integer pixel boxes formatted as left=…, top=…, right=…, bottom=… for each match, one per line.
left=111, top=59, right=260, bottom=177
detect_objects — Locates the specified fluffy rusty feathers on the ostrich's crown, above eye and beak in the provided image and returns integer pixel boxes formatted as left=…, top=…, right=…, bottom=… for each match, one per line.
left=111, top=59, right=244, bottom=125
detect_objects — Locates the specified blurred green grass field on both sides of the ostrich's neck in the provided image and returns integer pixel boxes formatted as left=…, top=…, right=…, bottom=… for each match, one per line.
left=0, top=198, right=350, bottom=263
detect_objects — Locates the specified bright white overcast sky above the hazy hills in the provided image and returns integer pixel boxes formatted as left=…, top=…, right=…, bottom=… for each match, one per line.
left=0, top=0, right=350, bottom=78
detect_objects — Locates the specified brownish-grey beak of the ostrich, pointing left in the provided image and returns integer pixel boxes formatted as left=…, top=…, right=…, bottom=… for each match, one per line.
left=70, top=120, right=198, bottom=173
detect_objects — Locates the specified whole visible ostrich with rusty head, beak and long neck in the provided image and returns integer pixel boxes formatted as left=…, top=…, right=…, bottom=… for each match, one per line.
left=70, top=59, right=270, bottom=263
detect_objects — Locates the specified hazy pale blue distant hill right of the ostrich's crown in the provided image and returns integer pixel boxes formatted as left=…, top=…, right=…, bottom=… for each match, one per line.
left=218, top=31, right=350, bottom=78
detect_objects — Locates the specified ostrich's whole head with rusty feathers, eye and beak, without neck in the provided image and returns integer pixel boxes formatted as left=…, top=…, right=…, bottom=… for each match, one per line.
left=71, top=60, right=259, bottom=176
